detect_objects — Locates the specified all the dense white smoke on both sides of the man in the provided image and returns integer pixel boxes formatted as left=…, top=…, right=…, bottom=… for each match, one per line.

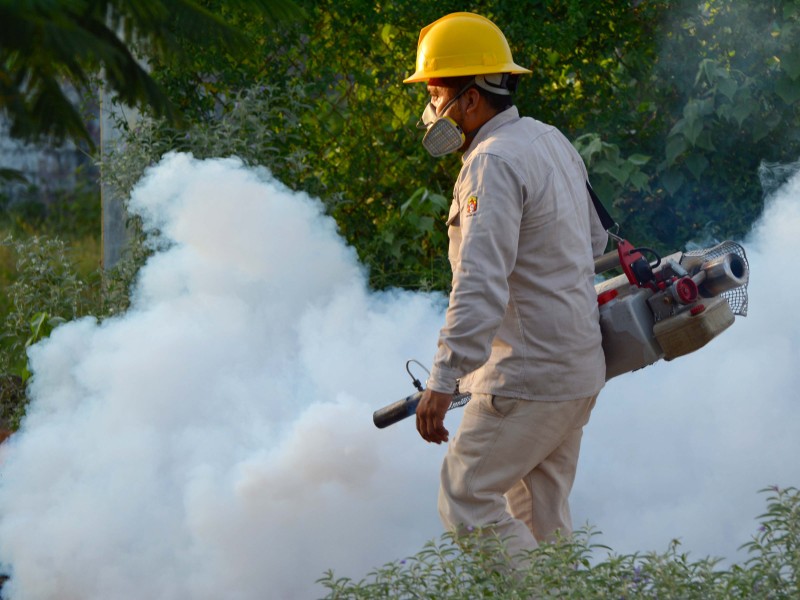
left=0, top=155, right=800, bottom=600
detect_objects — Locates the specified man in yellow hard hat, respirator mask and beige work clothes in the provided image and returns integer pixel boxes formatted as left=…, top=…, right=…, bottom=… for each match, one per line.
left=405, top=13, right=607, bottom=555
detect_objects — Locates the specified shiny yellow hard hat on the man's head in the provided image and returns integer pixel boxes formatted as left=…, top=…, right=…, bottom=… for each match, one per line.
left=403, top=12, right=530, bottom=83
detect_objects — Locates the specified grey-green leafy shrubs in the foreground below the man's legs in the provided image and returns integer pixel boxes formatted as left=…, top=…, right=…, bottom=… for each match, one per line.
left=319, top=487, right=800, bottom=600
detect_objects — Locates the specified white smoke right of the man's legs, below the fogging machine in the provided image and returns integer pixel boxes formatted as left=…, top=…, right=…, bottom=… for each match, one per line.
left=573, top=161, right=800, bottom=561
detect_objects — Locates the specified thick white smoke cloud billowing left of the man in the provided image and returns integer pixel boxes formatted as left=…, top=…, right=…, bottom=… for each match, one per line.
left=0, top=155, right=444, bottom=600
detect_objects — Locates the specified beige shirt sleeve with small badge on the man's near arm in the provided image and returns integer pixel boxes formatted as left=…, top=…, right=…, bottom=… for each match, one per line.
left=428, top=154, right=526, bottom=393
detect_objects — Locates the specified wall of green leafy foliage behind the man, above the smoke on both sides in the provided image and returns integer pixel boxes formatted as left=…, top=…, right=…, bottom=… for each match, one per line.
left=117, top=0, right=800, bottom=289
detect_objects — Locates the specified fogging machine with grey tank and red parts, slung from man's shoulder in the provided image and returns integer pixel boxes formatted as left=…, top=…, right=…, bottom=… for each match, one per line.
left=372, top=233, right=750, bottom=428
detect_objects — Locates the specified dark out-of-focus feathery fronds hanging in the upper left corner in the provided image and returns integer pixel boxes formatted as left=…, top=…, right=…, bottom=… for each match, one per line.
left=0, top=0, right=300, bottom=145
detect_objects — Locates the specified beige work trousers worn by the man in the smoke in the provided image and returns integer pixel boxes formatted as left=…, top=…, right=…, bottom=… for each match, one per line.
left=439, top=394, right=597, bottom=556
